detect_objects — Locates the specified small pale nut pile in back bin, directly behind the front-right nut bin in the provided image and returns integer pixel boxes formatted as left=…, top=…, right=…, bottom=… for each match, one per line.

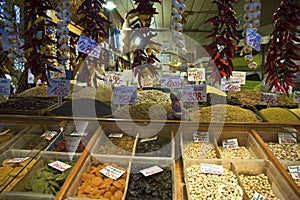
left=220, top=146, right=254, bottom=159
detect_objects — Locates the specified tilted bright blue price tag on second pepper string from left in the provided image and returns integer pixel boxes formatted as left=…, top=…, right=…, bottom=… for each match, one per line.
left=76, top=35, right=102, bottom=58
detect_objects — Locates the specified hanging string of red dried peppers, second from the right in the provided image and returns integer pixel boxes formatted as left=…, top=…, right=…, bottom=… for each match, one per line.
left=205, top=0, right=239, bottom=82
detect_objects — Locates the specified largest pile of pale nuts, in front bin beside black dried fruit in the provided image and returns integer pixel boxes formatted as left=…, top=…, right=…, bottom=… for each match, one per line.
left=186, top=165, right=243, bottom=200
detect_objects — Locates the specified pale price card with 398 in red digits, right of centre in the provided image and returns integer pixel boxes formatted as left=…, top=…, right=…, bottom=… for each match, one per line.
left=181, top=84, right=206, bottom=102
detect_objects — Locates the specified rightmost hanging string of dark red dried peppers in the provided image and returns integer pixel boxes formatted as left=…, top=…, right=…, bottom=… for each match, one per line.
left=264, top=0, right=300, bottom=95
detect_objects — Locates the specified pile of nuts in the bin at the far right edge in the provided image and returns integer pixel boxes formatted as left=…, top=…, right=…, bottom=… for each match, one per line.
left=267, top=142, right=300, bottom=161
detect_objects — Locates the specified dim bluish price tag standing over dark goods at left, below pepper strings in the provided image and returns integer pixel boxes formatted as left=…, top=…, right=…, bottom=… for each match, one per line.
left=48, top=79, right=70, bottom=97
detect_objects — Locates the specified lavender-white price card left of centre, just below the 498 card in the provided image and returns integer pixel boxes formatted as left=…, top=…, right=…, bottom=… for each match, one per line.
left=113, top=86, right=137, bottom=105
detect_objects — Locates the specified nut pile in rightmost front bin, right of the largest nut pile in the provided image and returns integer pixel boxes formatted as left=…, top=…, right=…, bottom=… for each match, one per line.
left=239, top=174, right=278, bottom=200
